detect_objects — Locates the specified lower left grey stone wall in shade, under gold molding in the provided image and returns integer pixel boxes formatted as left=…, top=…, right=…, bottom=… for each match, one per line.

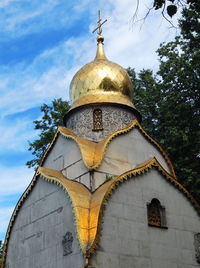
left=6, top=179, right=84, bottom=268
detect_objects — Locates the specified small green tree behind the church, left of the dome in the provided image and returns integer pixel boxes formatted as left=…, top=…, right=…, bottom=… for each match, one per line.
left=26, top=98, right=70, bottom=168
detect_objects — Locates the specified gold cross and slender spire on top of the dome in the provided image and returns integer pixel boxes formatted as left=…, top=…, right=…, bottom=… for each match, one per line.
left=92, top=10, right=107, bottom=60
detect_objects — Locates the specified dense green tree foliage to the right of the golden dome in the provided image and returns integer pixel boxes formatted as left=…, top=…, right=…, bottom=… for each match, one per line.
left=129, top=1, right=200, bottom=200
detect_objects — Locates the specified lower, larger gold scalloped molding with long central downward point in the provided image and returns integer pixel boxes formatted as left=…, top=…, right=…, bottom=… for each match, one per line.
left=3, top=158, right=200, bottom=266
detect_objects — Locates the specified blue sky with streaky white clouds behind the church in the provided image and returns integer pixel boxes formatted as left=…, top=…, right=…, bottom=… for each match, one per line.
left=0, top=0, right=176, bottom=239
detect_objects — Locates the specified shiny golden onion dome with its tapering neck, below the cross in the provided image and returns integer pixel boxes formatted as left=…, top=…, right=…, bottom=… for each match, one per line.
left=70, top=35, right=134, bottom=109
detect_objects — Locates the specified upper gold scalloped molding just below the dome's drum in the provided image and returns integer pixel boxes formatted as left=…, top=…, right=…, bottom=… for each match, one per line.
left=40, top=119, right=176, bottom=178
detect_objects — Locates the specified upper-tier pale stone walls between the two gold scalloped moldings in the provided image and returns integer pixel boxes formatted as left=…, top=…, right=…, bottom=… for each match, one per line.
left=43, top=128, right=170, bottom=190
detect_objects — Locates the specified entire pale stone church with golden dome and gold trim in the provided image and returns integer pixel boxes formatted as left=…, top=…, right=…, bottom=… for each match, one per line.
left=3, top=13, right=200, bottom=268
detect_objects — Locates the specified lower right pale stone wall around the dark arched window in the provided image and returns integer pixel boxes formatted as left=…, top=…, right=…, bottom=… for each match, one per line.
left=91, top=169, right=200, bottom=268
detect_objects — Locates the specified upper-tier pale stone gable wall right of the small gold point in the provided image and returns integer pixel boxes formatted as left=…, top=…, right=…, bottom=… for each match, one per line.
left=99, top=128, right=170, bottom=175
